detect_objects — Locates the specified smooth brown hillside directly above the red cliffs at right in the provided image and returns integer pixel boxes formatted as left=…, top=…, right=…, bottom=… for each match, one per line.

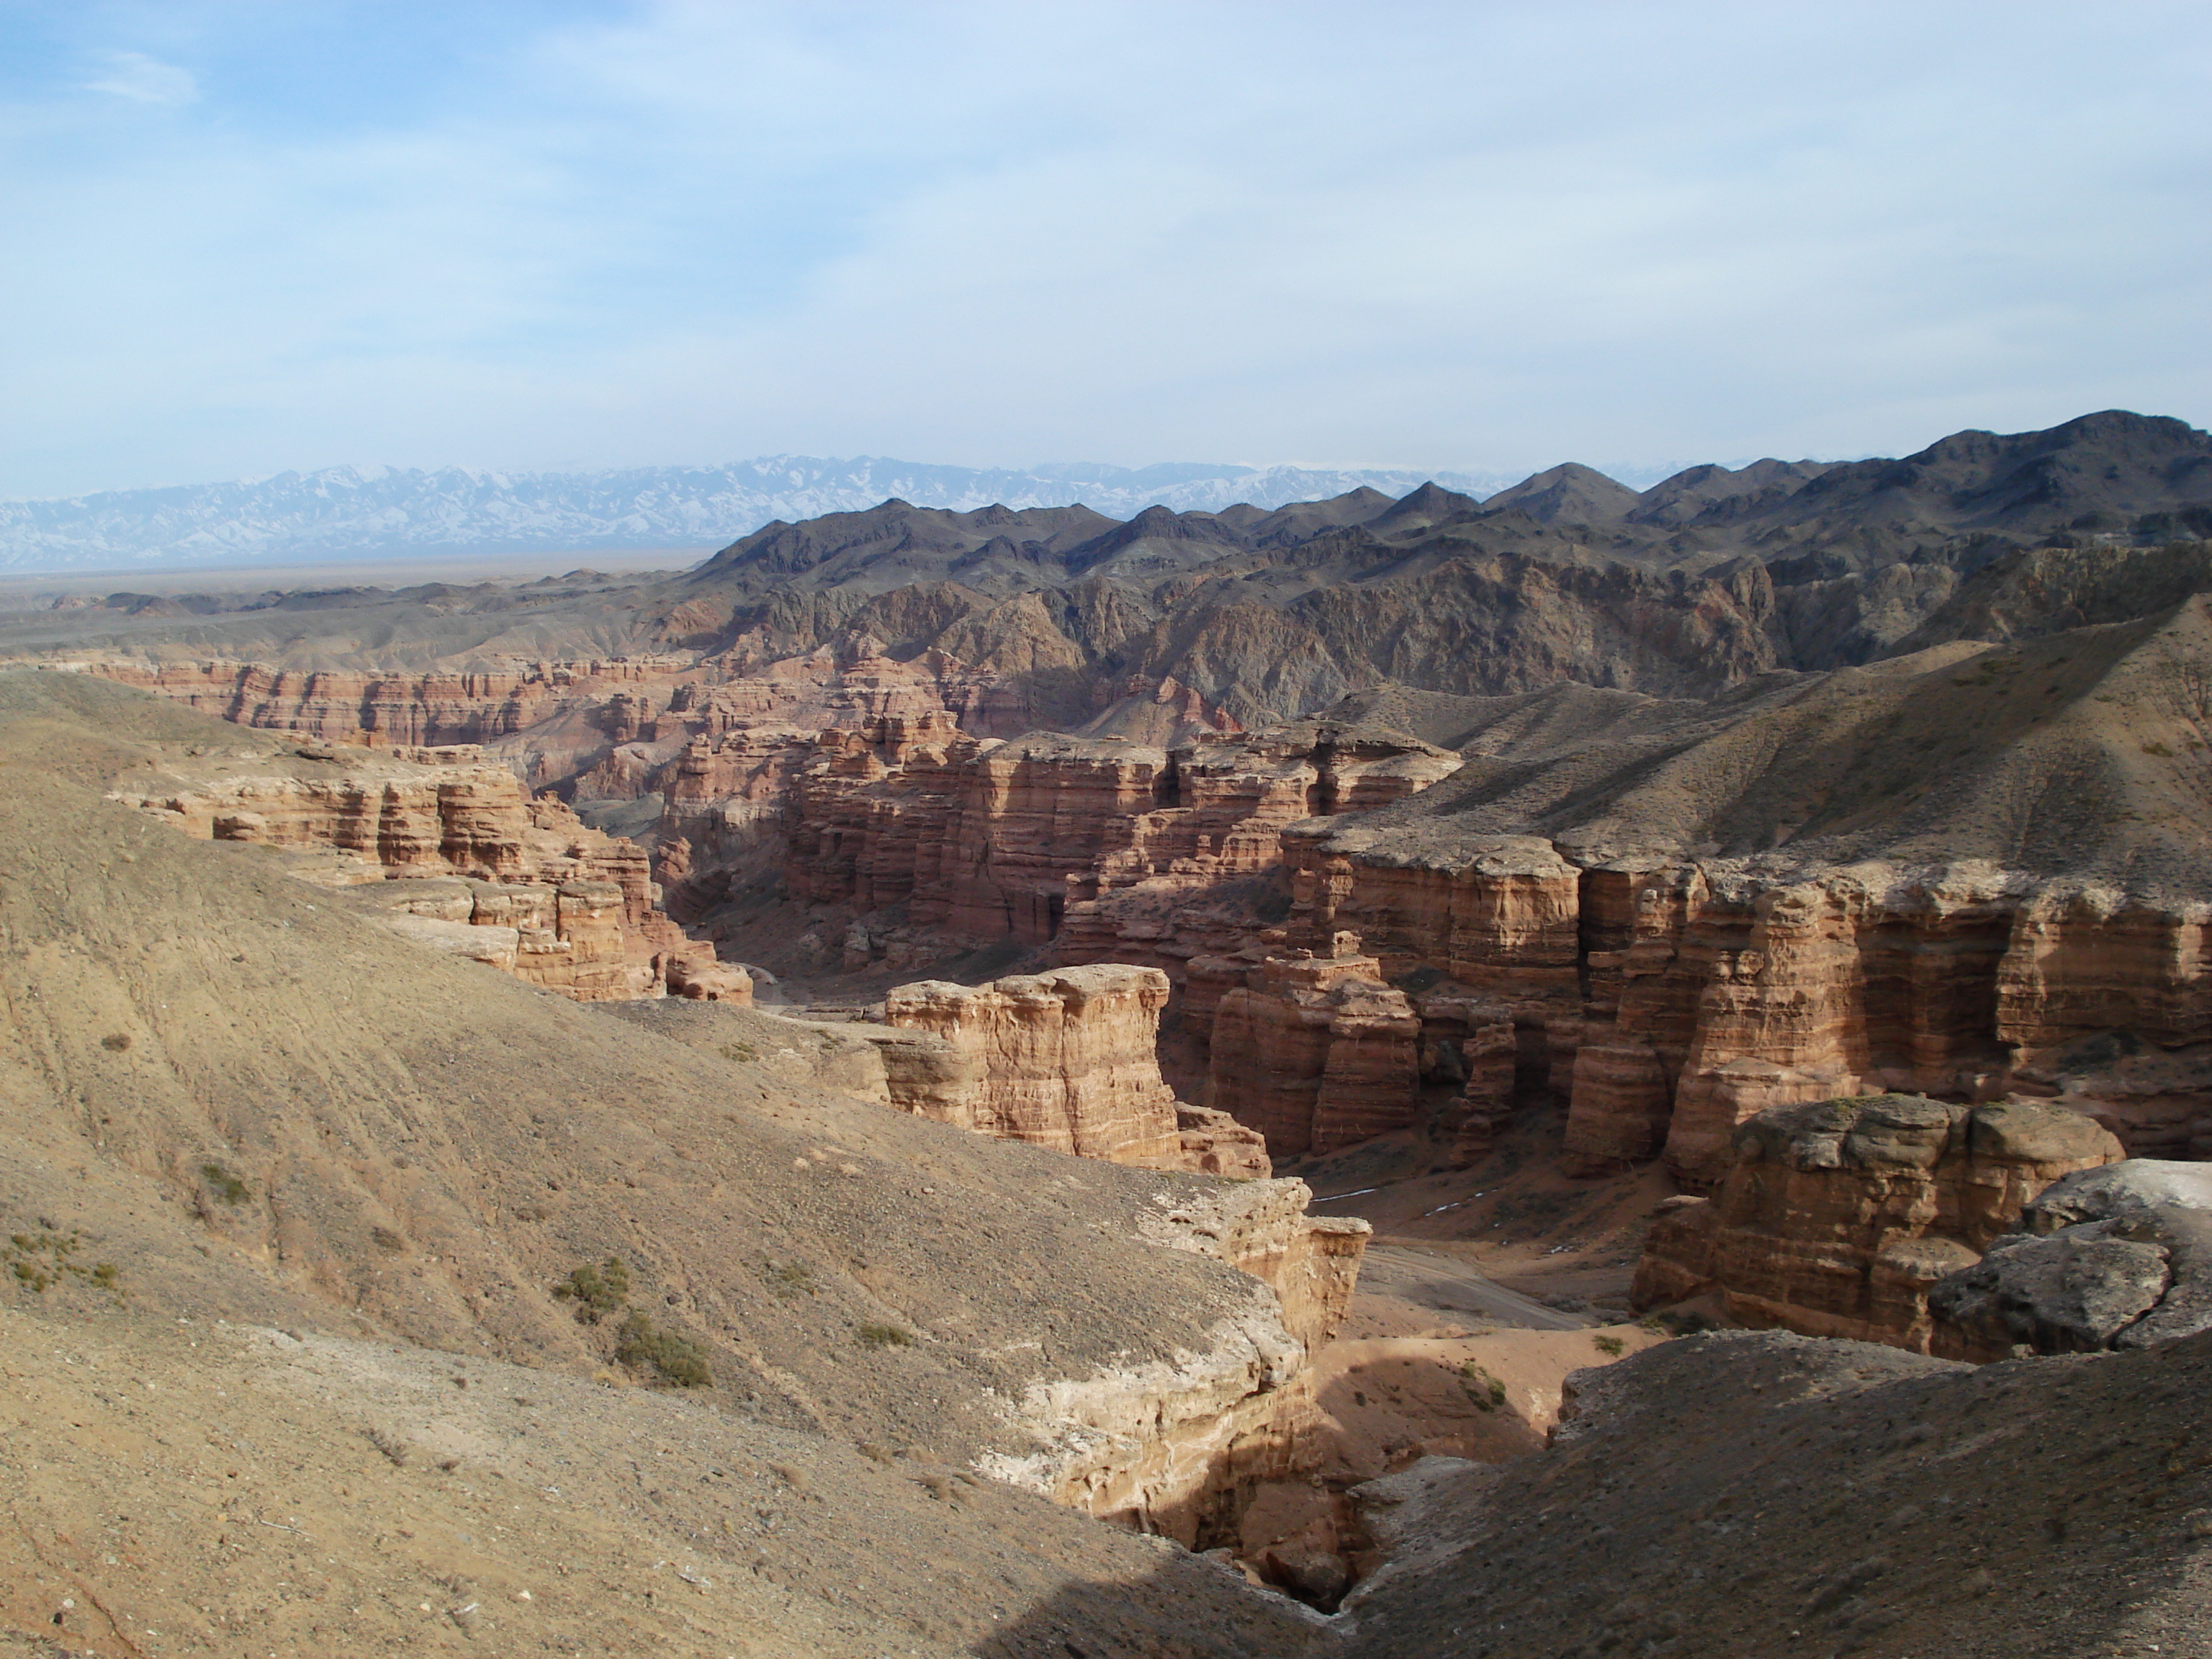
left=1336, top=595, right=2212, bottom=894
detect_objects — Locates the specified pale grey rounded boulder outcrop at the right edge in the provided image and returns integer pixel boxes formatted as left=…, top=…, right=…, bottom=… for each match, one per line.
left=1929, top=1159, right=2212, bottom=1360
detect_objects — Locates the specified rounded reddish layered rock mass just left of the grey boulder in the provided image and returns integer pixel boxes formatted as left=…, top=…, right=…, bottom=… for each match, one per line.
left=1635, top=1095, right=2121, bottom=1354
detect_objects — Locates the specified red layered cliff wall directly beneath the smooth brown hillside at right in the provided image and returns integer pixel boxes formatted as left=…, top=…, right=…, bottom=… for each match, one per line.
left=1283, top=821, right=2212, bottom=1188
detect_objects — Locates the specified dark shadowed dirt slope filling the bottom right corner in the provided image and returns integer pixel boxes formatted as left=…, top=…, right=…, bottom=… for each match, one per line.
left=1345, top=1331, right=2212, bottom=1659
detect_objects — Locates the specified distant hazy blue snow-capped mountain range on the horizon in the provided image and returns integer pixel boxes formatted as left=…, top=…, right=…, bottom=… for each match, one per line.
left=0, top=456, right=1513, bottom=573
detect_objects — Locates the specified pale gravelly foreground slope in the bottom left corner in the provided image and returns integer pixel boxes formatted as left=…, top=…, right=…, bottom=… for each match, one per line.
left=0, top=1309, right=1318, bottom=1659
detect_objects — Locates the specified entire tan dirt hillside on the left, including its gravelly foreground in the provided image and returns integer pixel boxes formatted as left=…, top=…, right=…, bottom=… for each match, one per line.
left=0, top=675, right=1305, bottom=1653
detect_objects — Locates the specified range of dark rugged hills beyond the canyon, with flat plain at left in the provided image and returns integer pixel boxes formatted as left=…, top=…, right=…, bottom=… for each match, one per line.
left=0, top=411, right=2212, bottom=752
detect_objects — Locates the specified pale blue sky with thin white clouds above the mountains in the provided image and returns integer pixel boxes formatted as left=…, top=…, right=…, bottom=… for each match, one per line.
left=0, top=0, right=2212, bottom=495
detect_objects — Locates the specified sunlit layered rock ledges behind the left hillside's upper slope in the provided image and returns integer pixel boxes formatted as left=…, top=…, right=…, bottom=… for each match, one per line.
left=113, top=745, right=734, bottom=1002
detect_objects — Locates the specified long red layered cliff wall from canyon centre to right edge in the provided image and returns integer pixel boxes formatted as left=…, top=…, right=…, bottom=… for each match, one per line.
left=790, top=728, right=2212, bottom=1188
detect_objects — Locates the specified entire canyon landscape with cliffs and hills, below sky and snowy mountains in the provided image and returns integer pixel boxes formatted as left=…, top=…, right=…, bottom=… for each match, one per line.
left=13, top=416, right=2212, bottom=1659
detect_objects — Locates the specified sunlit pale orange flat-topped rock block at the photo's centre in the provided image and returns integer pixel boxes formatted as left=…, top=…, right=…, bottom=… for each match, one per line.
left=876, top=964, right=1269, bottom=1185
